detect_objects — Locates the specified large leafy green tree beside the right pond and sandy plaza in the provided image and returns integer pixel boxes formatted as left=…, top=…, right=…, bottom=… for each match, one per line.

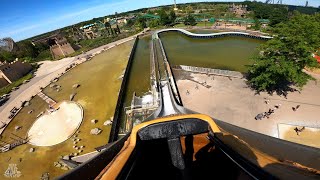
left=248, top=14, right=320, bottom=94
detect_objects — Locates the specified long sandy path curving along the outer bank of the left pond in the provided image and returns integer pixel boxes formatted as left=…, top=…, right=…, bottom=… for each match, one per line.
left=0, top=33, right=142, bottom=135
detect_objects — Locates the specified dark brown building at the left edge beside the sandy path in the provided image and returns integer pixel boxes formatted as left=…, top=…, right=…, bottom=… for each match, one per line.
left=0, top=60, right=32, bottom=88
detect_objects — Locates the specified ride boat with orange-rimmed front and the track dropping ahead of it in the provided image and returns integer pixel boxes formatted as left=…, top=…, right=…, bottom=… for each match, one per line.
left=59, top=31, right=320, bottom=179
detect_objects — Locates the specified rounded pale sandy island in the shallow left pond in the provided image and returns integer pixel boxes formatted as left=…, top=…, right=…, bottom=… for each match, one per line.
left=28, top=101, right=83, bottom=146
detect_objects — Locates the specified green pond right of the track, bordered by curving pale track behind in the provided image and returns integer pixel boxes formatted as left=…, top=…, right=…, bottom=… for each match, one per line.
left=160, top=31, right=265, bottom=72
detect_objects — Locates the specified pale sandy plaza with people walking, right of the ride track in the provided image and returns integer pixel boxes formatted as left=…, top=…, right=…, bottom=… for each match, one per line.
left=176, top=71, right=320, bottom=137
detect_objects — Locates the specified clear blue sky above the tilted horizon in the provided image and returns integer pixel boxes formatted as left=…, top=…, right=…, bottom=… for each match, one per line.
left=0, top=0, right=320, bottom=41
